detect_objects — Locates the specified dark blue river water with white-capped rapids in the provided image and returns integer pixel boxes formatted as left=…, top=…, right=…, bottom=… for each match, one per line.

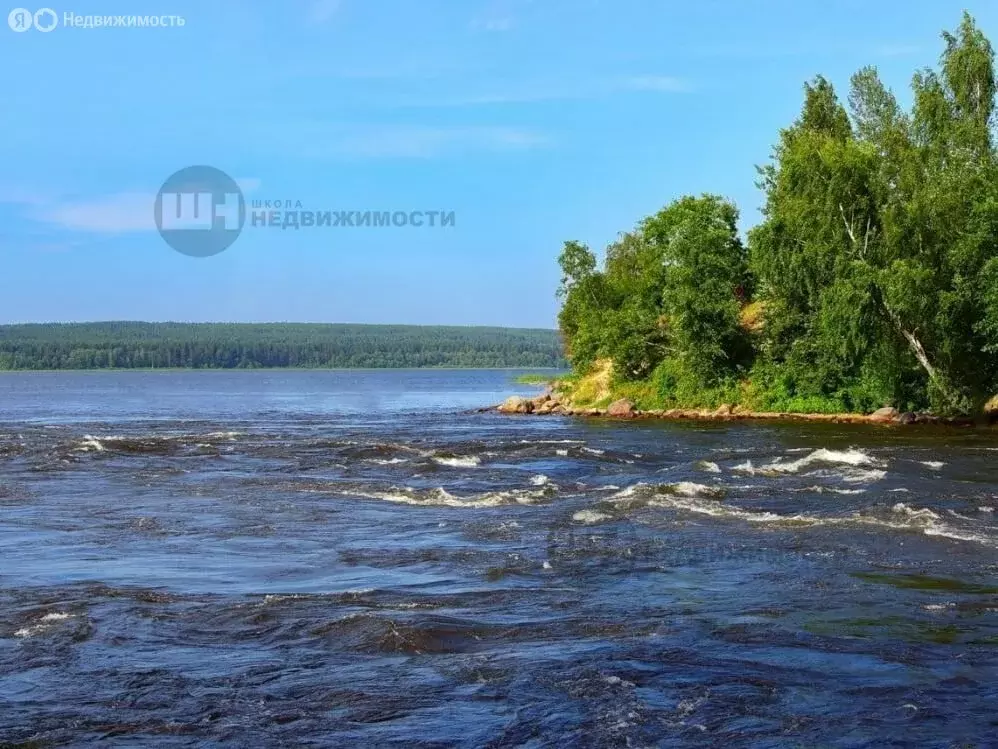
left=0, top=371, right=998, bottom=747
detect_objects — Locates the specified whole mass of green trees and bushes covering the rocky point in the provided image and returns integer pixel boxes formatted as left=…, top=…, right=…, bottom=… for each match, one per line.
left=559, top=15, right=998, bottom=413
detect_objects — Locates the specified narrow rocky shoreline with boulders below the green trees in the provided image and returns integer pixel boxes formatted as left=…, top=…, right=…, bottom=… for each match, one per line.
left=490, top=388, right=977, bottom=426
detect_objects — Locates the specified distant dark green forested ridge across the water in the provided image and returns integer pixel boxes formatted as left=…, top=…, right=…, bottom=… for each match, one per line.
left=0, top=322, right=564, bottom=369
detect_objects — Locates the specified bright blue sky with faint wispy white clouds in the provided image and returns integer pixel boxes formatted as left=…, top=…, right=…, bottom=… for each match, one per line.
left=0, top=0, right=998, bottom=327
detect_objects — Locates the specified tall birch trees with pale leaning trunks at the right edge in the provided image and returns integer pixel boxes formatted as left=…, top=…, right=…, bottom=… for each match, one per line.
left=750, top=16, right=998, bottom=411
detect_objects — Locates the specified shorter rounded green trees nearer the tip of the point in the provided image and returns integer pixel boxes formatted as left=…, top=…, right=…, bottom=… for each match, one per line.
left=559, top=195, right=749, bottom=387
